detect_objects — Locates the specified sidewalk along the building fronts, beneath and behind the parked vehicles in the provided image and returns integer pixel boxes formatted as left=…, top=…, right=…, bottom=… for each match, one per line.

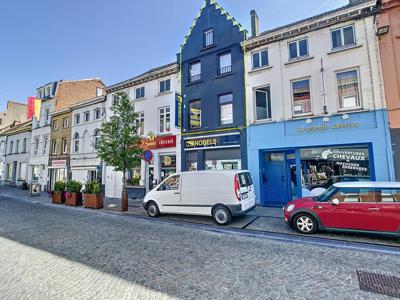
left=0, top=186, right=400, bottom=247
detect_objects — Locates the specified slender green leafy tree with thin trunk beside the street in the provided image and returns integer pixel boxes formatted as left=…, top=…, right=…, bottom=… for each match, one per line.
left=95, top=92, right=142, bottom=211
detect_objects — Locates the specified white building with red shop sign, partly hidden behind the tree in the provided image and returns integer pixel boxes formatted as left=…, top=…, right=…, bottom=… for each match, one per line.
left=104, top=63, right=181, bottom=198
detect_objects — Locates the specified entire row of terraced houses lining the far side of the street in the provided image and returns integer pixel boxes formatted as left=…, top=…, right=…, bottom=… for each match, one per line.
left=0, top=0, right=400, bottom=205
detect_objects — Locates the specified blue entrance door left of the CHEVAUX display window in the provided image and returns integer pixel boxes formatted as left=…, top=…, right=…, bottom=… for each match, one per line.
left=261, top=152, right=290, bottom=206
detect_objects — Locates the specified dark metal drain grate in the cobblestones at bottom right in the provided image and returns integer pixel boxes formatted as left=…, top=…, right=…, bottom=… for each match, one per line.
left=357, top=271, right=400, bottom=298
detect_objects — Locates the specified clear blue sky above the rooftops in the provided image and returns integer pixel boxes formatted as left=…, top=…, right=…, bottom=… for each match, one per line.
left=0, top=0, right=348, bottom=111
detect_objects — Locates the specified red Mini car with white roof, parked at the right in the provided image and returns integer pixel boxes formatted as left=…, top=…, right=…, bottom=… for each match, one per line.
left=283, top=181, right=400, bottom=235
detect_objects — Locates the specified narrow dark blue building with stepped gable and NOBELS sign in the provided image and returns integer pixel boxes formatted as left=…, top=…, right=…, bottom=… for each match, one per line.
left=177, top=0, right=247, bottom=171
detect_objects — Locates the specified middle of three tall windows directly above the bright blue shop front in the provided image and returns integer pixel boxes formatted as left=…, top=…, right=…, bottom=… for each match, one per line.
left=292, top=79, right=311, bottom=116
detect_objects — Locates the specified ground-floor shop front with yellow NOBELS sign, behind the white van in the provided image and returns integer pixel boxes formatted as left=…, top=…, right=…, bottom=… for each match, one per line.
left=183, top=132, right=246, bottom=171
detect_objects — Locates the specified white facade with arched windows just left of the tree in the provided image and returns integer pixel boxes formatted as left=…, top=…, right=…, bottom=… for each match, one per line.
left=70, top=96, right=106, bottom=183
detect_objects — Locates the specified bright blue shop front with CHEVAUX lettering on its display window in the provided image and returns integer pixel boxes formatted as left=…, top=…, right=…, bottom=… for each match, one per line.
left=248, top=111, right=394, bottom=206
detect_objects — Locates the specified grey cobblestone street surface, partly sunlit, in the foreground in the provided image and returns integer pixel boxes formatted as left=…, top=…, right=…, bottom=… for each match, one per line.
left=0, top=188, right=400, bottom=299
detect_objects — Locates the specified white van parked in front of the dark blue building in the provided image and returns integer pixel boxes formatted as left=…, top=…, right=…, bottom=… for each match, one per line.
left=143, top=170, right=256, bottom=225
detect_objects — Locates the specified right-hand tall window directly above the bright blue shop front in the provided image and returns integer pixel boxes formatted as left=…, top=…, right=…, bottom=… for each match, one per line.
left=336, top=70, right=361, bottom=109
